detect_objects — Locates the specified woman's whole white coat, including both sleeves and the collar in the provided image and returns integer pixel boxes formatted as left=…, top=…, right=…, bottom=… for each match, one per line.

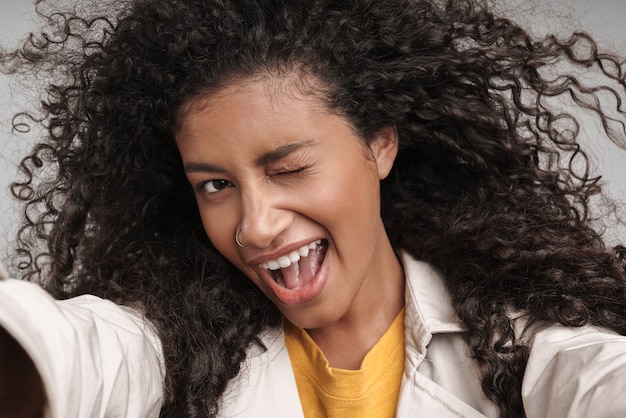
left=0, top=253, right=626, bottom=418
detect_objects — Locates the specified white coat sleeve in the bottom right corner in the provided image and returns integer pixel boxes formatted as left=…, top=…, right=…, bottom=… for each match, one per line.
left=522, top=326, right=626, bottom=418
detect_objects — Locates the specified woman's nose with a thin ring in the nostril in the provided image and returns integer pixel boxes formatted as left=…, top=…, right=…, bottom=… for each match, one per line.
left=238, top=185, right=293, bottom=248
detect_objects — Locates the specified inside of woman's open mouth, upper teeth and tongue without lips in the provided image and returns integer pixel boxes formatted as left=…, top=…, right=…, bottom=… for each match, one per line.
left=259, top=240, right=328, bottom=290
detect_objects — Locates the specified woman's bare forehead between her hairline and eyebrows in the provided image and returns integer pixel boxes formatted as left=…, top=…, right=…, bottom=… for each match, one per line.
left=176, top=72, right=364, bottom=160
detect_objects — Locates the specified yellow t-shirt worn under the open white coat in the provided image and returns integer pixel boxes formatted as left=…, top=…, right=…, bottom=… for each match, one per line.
left=284, top=309, right=404, bottom=418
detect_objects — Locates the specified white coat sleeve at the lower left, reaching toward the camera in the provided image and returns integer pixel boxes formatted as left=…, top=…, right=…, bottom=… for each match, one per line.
left=0, top=280, right=164, bottom=418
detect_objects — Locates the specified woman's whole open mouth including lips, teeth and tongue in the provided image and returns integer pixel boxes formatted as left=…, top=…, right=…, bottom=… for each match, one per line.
left=259, top=240, right=328, bottom=304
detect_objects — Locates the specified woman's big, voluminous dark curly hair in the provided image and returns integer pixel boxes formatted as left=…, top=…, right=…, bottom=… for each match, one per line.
left=3, top=0, right=626, bottom=417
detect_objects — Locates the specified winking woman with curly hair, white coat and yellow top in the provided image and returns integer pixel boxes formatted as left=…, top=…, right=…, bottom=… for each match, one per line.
left=0, top=0, right=626, bottom=417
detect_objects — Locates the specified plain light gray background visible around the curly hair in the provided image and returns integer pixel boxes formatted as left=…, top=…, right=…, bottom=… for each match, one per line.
left=0, top=0, right=626, bottom=278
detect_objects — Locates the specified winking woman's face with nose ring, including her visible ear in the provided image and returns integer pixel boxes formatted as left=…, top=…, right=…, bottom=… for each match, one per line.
left=176, top=78, right=399, bottom=328
